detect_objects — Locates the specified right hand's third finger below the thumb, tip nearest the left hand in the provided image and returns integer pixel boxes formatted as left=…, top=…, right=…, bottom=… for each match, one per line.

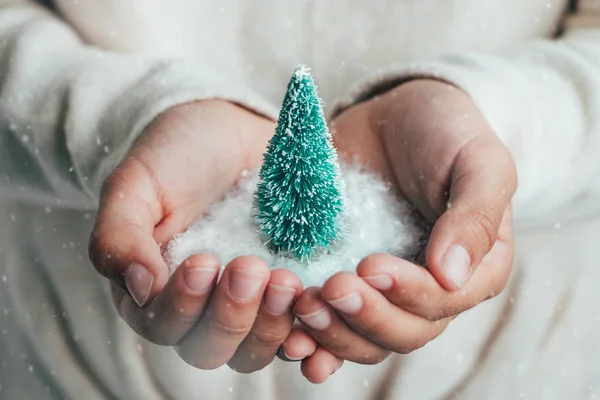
left=294, top=287, right=389, bottom=364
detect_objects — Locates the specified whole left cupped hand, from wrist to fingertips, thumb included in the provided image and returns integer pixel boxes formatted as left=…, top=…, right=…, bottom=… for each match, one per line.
left=89, top=101, right=304, bottom=372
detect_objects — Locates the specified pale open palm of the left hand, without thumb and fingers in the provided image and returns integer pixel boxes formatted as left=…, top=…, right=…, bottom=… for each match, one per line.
left=125, top=102, right=274, bottom=243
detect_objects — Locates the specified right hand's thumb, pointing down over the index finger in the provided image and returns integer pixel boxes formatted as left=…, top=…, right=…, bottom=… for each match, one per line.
left=426, top=135, right=517, bottom=291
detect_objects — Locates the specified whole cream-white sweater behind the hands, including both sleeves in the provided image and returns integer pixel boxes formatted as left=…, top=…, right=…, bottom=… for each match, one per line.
left=0, top=0, right=600, bottom=400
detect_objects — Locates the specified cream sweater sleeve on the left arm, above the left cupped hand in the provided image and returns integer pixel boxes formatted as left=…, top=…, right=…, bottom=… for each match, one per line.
left=0, top=0, right=276, bottom=209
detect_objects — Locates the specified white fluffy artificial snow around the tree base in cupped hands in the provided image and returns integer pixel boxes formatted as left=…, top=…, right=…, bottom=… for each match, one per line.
left=165, top=165, right=426, bottom=286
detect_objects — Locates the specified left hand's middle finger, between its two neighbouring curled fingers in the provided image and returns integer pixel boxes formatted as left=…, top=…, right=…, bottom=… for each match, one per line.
left=176, top=256, right=269, bottom=369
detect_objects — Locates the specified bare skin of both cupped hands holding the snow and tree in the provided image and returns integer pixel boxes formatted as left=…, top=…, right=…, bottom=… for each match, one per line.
left=90, top=80, right=517, bottom=383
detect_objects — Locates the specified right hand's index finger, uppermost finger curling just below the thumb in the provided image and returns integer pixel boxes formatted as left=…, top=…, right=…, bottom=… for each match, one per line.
left=357, top=211, right=513, bottom=321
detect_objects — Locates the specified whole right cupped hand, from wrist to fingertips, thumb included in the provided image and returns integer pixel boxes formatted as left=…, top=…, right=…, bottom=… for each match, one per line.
left=286, top=80, right=517, bottom=370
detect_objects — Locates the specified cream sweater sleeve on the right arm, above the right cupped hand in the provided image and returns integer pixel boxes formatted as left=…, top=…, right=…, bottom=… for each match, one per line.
left=334, top=0, right=600, bottom=226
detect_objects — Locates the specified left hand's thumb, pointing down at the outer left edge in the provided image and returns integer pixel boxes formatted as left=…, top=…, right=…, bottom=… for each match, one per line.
left=89, top=158, right=169, bottom=306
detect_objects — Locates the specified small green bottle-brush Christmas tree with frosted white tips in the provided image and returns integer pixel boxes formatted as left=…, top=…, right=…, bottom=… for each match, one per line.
left=254, top=66, right=343, bottom=260
